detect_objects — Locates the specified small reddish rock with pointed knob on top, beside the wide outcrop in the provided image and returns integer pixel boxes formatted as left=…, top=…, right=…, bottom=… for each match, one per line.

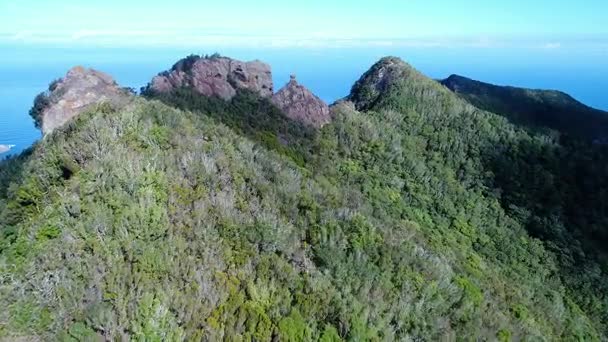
left=272, top=75, right=331, bottom=127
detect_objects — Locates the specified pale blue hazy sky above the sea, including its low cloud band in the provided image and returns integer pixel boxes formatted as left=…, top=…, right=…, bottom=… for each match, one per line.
left=0, top=0, right=608, bottom=48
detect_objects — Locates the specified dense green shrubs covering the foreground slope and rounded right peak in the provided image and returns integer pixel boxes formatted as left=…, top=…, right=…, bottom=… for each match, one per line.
left=0, top=58, right=608, bottom=341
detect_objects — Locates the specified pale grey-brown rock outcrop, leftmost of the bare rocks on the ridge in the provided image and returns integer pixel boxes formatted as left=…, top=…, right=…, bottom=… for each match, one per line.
left=35, top=66, right=130, bottom=134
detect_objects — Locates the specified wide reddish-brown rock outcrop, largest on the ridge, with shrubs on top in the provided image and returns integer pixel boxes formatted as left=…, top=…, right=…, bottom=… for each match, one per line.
left=148, top=56, right=273, bottom=100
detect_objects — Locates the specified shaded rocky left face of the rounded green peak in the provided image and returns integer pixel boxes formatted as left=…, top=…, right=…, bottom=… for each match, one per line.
left=347, top=57, right=417, bottom=110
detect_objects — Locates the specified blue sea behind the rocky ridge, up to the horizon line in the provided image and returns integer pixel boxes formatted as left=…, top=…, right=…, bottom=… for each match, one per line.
left=0, top=46, right=608, bottom=155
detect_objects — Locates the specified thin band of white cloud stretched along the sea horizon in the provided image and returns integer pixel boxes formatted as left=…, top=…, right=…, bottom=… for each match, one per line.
left=0, top=28, right=605, bottom=49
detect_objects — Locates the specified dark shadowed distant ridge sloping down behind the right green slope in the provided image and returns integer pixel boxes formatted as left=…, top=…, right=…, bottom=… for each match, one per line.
left=441, top=75, right=608, bottom=143
